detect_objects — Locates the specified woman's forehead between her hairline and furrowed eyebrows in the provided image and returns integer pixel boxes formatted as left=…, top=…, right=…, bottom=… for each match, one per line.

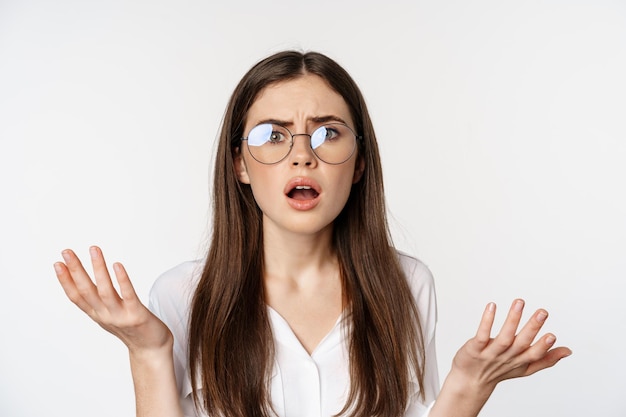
left=246, top=74, right=353, bottom=128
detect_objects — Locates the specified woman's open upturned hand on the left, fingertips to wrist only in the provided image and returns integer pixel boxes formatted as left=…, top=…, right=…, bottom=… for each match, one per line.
left=54, top=246, right=173, bottom=354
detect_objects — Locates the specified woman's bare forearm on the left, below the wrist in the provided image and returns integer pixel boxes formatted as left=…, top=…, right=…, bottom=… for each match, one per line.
left=130, top=345, right=183, bottom=417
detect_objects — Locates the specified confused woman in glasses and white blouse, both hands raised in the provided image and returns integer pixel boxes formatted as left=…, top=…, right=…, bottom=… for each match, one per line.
left=55, top=52, right=571, bottom=417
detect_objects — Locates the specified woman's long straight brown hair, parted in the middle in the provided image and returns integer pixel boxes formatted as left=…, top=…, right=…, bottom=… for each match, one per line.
left=189, top=51, right=424, bottom=417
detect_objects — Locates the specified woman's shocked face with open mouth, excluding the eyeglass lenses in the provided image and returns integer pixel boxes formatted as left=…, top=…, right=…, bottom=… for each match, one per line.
left=235, top=74, right=363, bottom=234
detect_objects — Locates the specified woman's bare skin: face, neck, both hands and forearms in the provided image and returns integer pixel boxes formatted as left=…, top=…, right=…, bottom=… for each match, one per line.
left=54, top=75, right=571, bottom=417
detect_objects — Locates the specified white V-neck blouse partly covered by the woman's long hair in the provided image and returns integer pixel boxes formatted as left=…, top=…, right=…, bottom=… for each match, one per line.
left=149, top=253, right=439, bottom=417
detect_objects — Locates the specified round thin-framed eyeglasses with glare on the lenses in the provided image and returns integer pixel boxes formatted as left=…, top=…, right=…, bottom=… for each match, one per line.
left=241, top=123, right=361, bottom=165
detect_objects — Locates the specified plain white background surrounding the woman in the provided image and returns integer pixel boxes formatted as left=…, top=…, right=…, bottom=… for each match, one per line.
left=0, top=0, right=626, bottom=417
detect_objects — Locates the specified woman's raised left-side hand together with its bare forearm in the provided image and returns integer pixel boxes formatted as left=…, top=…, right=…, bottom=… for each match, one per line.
left=54, top=246, right=183, bottom=417
